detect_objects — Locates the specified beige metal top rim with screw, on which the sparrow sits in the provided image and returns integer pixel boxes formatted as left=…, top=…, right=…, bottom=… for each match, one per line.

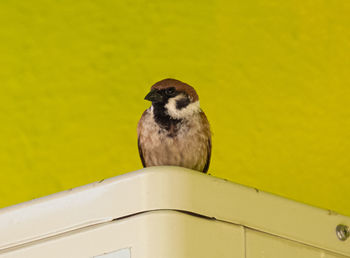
left=0, top=167, right=350, bottom=256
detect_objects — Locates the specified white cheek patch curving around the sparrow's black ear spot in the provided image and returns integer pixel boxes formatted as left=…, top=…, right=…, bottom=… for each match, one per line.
left=165, top=95, right=200, bottom=119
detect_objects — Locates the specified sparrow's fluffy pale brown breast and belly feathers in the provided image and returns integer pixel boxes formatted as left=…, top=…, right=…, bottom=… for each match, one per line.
left=138, top=108, right=210, bottom=170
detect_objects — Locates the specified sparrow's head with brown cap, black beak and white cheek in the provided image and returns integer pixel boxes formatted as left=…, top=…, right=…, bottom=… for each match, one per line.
left=145, top=79, right=200, bottom=119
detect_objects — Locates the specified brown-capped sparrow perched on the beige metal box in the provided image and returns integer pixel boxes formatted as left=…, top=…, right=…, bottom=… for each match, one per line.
left=137, top=79, right=211, bottom=173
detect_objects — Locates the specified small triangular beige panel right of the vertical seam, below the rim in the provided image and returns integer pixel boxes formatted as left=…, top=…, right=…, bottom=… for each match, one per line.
left=246, top=229, right=349, bottom=258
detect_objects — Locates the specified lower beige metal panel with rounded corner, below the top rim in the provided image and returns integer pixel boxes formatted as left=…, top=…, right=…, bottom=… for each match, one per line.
left=0, top=211, right=244, bottom=258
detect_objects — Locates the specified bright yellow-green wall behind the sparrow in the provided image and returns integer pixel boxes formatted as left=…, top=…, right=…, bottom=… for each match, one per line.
left=0, top=0, right=350, bottom=215
